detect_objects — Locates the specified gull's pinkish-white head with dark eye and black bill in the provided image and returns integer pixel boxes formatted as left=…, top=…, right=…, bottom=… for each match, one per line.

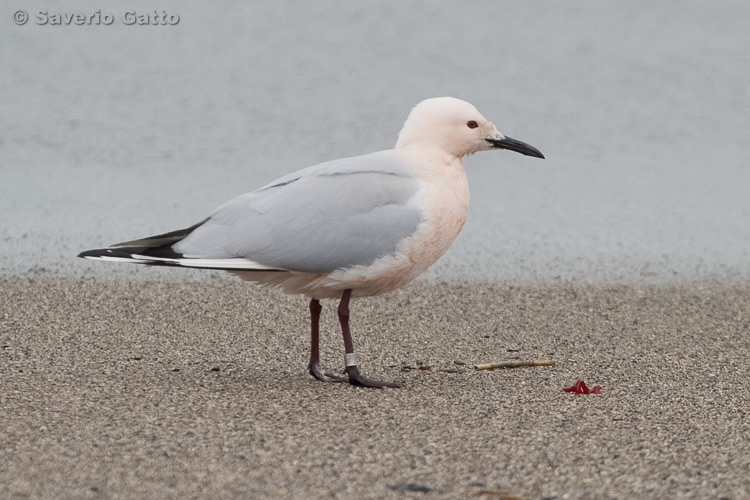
left=396, top=97, right=544, bottom=158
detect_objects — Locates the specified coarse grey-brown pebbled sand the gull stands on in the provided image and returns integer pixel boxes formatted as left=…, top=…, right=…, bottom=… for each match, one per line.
left=0, top=275, right=750, bottom=500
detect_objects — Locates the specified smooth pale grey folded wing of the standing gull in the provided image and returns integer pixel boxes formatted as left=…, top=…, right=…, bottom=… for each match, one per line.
left=173, top=150, right=422, bottom=273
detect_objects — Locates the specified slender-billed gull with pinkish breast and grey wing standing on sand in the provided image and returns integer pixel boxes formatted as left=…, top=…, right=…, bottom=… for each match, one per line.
left=78, top=97, right=544, bottom=387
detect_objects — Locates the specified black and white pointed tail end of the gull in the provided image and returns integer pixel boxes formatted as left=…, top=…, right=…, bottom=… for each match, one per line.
left=78, top=219, right=281, bottom=271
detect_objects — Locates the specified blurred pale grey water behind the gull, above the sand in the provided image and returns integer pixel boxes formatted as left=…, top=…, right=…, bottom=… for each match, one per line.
left=0, top=0, right=750, bottom=283
